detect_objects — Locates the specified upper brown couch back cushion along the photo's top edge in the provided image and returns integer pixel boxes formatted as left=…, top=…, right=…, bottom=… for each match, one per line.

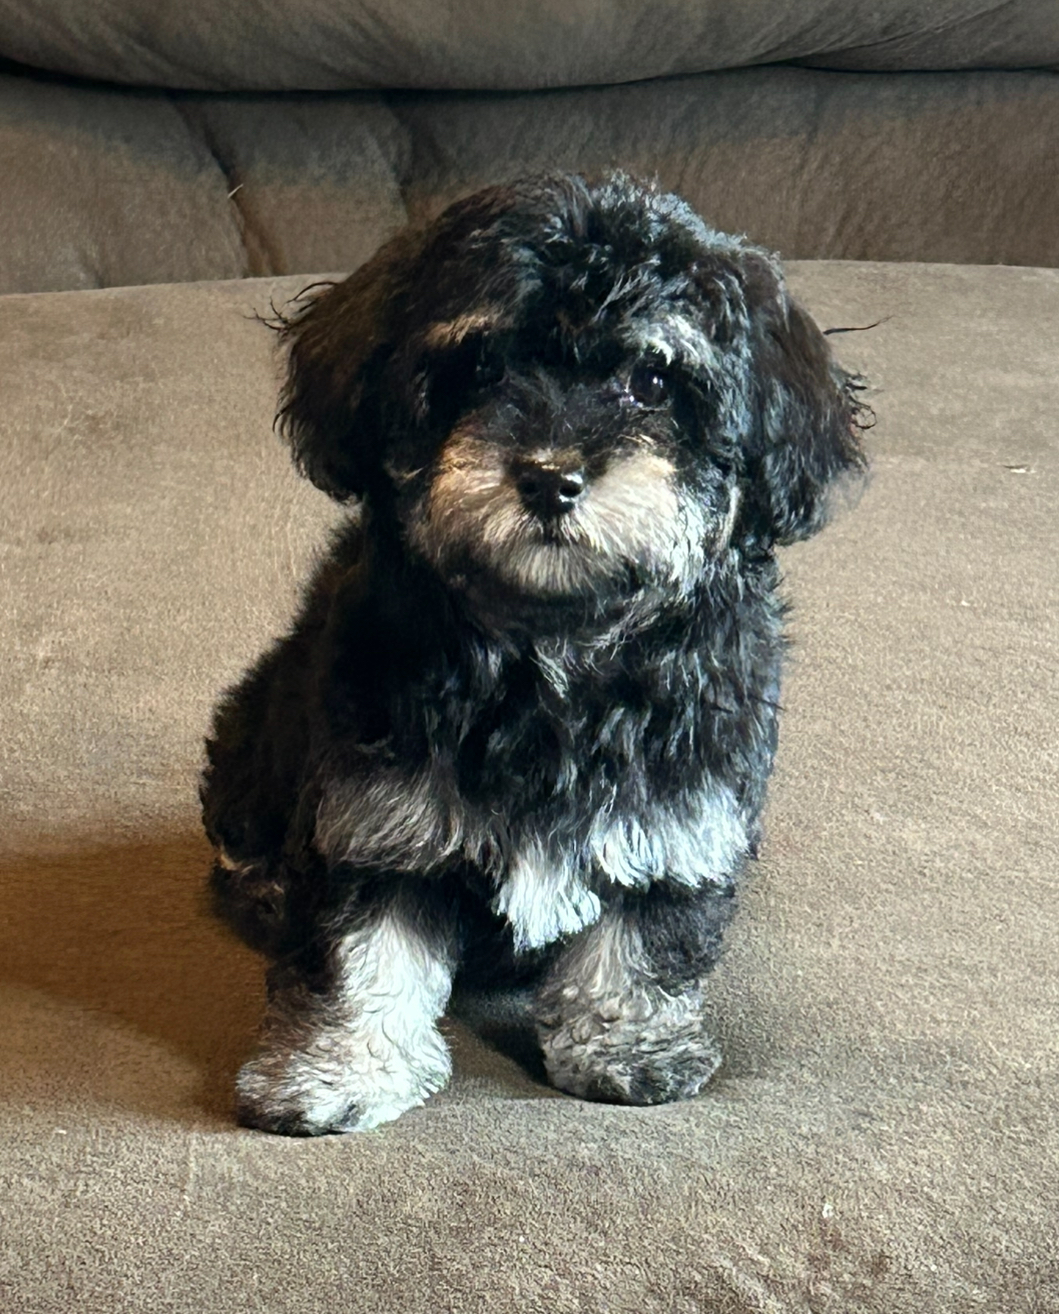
left=0, top=0, right=1059, bottom=91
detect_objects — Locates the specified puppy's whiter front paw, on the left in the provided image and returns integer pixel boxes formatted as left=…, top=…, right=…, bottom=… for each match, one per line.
left=235, top=1028, right=452, bottom=1137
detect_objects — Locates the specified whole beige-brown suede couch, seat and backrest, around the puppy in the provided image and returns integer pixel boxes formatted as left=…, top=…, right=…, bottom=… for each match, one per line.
left=0, top=0, right=1059, bottom=1314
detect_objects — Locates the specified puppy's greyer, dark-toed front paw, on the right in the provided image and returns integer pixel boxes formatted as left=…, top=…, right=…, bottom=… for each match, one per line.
left=537, top=997, right=721, bottom=1104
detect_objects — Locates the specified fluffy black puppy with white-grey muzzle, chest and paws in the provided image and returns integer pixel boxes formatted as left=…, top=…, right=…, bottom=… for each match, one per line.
left=202, top=176, right=865, bottom=1135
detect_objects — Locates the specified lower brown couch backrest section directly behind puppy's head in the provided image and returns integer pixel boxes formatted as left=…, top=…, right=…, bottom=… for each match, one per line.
left=0, top=37, right=1059, bottom=292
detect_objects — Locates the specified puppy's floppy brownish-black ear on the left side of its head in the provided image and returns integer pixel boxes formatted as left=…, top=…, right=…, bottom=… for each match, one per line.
left=276, top=233, right=418, bottom=502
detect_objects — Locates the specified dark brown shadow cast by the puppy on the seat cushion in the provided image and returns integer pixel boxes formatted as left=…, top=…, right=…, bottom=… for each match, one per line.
left=0, top=832, right=554, bottom=1125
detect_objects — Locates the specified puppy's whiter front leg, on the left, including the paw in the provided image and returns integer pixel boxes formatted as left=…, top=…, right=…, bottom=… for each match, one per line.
left=237, top=882, right=456, bottom=1135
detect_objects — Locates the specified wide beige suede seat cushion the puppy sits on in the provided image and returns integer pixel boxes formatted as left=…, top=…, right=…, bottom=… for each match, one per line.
left=0, top=264, right=1059, bottom=1314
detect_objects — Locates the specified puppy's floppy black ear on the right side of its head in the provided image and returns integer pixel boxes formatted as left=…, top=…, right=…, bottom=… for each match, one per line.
left=744, top=255, right=868, bottom=544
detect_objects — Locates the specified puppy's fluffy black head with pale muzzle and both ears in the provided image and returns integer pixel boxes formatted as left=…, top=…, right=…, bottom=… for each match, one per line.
left=280, top=176, right=863, bottom=620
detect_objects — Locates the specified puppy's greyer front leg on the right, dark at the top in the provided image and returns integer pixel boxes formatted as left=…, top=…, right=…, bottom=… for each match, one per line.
left=536, top=886, right=734, bottom=1104
